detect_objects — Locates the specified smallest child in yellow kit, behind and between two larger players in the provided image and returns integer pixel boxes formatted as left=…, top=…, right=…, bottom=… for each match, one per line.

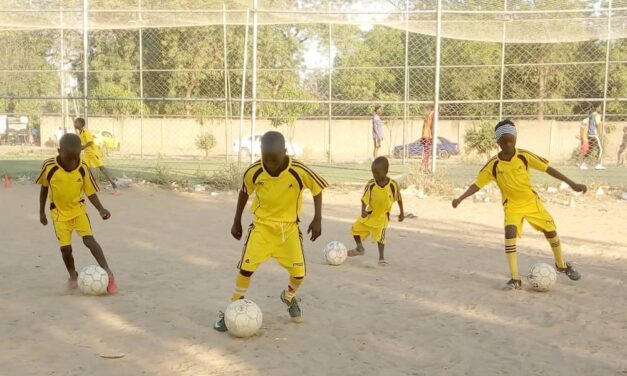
left=348, top=157, right=405, bottom=266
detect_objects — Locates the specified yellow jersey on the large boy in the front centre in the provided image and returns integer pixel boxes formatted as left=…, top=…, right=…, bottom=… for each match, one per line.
left=242, top=158, right=327, bottom=222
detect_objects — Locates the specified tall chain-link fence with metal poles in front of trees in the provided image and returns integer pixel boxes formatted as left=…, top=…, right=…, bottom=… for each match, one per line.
left=0, top=0, right=627, bottom=168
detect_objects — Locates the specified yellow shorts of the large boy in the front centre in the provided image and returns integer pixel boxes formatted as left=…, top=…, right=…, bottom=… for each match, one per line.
left=237, top=220, right=307, bottom=277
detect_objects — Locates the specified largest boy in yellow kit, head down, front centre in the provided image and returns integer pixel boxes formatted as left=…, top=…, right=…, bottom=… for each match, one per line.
left=213, top=132, right=327, bottom=332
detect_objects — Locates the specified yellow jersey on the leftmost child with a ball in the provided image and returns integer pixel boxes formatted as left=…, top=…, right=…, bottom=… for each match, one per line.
left=36, top=158, right=99, bottom=221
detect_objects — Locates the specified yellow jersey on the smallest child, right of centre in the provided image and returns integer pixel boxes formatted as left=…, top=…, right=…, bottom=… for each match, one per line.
left=361, top=179, right=399, bottom=228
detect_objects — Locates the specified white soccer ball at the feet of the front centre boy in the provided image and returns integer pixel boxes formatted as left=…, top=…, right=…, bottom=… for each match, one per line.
left=224, top=299, right=263, bottom=338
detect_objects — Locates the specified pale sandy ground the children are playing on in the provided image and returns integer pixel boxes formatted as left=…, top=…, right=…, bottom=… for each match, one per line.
left=0, top=185, right=627, bottom=376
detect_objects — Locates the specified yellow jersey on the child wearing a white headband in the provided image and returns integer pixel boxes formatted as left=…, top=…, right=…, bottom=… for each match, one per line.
left=475, top=149, right=549, bottom=205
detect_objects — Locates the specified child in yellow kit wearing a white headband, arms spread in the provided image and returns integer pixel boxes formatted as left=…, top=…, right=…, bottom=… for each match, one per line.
left=453, top=120, right=587, bottom=290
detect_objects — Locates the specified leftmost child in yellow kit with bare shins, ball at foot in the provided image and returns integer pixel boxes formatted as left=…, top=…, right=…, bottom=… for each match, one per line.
left=37, top=133, right=118, bottom=294
